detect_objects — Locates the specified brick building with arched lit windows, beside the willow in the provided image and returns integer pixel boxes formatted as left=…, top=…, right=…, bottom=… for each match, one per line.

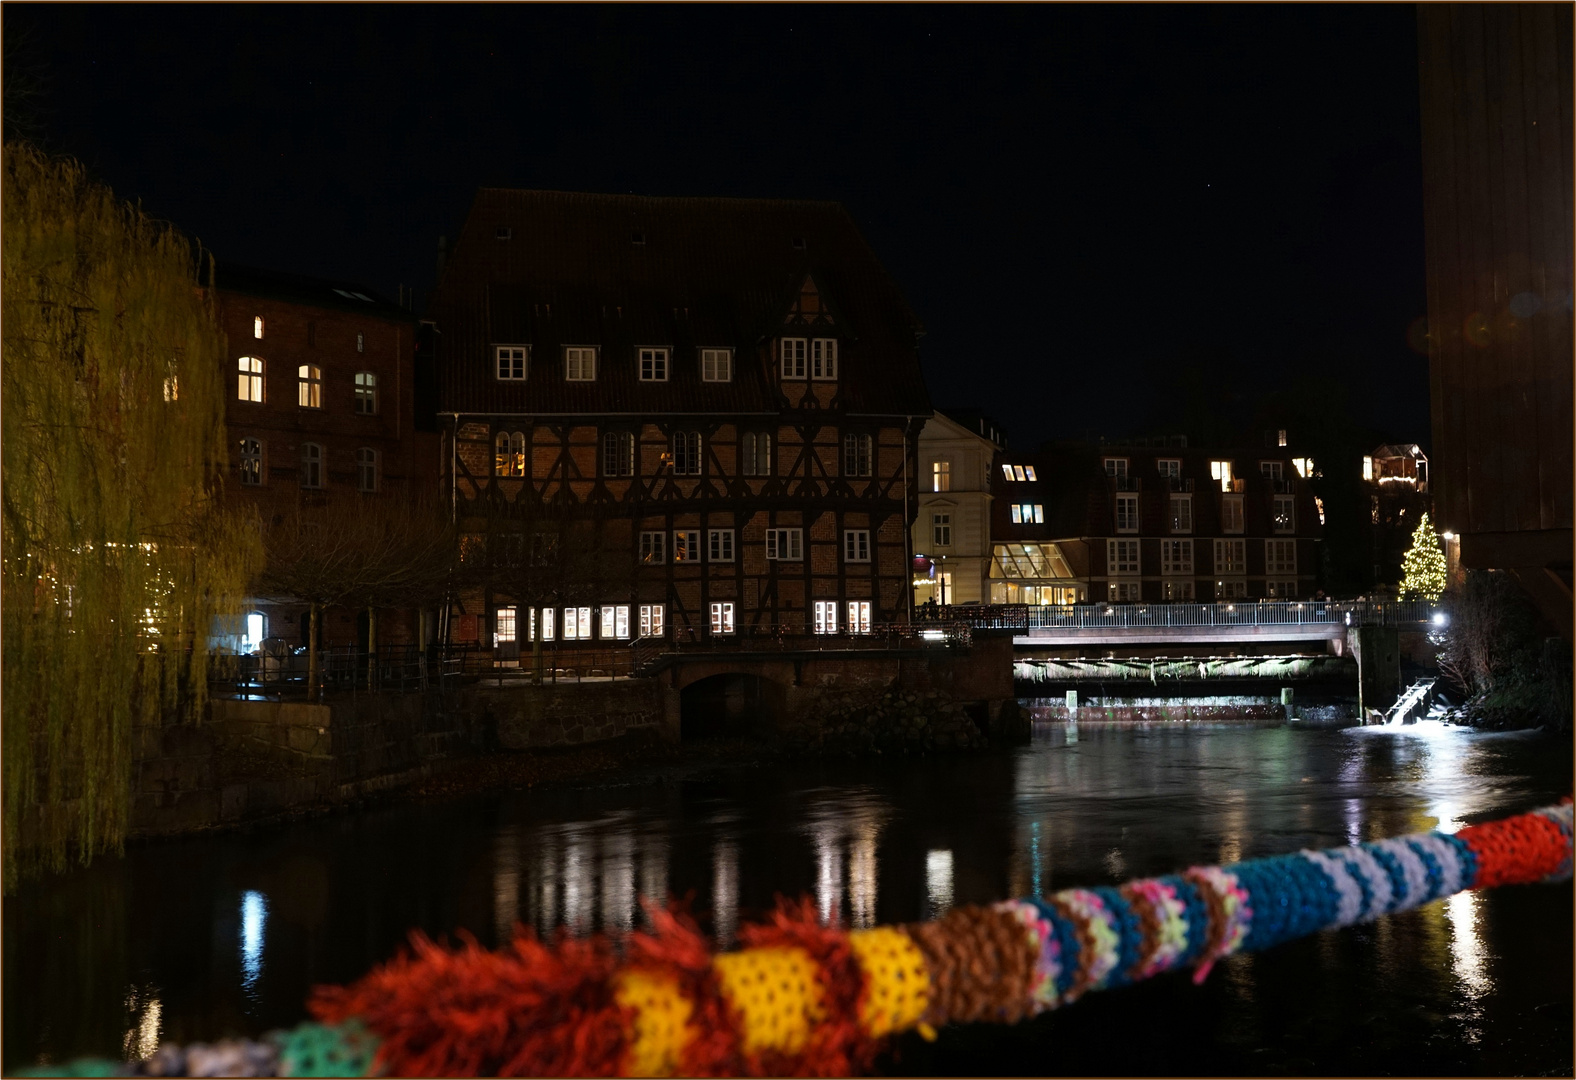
left=216, top=263, right=438, bottom=651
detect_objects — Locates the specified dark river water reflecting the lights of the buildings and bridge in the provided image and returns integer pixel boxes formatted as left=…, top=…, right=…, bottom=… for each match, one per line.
left=3, top=722, right=1573, bottom=1075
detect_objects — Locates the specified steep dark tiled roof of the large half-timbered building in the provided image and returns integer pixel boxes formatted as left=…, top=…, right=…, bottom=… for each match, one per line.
left=427, top=188, right=930, bottom=415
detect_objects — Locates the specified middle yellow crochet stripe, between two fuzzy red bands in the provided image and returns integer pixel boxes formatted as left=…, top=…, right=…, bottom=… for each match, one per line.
left=711, top=948, right=826, bottom=1053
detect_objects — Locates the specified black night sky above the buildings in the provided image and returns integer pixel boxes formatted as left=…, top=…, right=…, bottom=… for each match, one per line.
left=5, top=3, right=1428, bottom=448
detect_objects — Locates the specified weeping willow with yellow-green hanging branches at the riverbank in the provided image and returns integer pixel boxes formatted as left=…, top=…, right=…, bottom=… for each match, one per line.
left=0, top=145, right=262, bottom=891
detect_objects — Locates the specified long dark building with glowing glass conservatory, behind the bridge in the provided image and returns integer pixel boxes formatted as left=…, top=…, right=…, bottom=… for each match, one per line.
left=990, top=437, right=1321, bottom=604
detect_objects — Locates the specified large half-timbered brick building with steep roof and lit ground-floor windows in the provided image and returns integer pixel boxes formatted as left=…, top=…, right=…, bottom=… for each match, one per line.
left=429, top=189, right=930, bottom=657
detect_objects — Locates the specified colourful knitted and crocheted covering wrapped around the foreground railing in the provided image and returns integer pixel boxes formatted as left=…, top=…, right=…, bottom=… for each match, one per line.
left=20, top=799, right=1573, bottom=1077
